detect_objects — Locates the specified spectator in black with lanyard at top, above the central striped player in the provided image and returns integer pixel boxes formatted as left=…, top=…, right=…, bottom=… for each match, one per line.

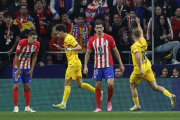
left=109, top=0, right=130, bottom=24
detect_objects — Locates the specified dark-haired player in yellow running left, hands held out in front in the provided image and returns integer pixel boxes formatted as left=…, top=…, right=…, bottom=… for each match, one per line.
left=52, top=24, right=103, bottom=110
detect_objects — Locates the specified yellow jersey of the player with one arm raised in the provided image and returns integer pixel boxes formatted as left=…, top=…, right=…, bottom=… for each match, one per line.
left=131, top=37, right=151, bottom=74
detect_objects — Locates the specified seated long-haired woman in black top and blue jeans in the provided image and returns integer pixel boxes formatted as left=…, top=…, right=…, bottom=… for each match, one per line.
left=154, top=14, right=180, bottom=64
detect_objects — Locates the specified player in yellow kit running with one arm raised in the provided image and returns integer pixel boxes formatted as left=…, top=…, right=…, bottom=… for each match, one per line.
left=130, top=18, right=176, bottom=111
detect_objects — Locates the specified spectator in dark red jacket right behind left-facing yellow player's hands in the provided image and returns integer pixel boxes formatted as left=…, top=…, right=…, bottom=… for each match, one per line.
left=49, top=26, right=66, bottom=64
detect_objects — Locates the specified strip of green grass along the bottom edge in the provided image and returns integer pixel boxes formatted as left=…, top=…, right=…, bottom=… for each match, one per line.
left=0, top=111, right=180, bottom=120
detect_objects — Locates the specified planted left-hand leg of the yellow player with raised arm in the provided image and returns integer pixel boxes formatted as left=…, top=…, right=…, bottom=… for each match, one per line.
left=130, top=73, right=142, bottom=111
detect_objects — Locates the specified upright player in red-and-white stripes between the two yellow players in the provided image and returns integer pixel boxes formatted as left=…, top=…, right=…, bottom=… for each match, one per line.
left=84, top=22, right=124, bottom=112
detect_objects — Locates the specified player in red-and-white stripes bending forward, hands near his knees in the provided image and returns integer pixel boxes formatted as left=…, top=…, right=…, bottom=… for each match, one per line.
left=12, top=31, right=40, bottom=113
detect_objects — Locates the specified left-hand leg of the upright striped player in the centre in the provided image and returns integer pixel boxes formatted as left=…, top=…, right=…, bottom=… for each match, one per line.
left=93, top=68, right=103, bottom=112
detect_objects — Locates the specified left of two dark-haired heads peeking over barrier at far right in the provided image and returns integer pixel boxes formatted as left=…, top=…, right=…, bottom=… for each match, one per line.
left=159, top=66, right=171, bottom=78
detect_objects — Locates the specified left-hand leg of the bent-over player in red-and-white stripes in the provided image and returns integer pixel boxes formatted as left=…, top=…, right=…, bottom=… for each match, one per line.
left=12, top=67, right=22, bottom=112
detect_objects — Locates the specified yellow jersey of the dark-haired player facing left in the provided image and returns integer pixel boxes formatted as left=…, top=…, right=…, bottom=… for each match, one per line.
left=64, top=34, right=82, bottom=66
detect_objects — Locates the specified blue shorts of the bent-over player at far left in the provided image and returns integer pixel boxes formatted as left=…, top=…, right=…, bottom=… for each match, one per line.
left=12, top=67, right=31, bottom=83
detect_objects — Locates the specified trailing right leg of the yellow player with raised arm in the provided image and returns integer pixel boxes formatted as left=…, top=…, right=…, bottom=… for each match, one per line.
left=144, top=69, right=176, bottom=108
